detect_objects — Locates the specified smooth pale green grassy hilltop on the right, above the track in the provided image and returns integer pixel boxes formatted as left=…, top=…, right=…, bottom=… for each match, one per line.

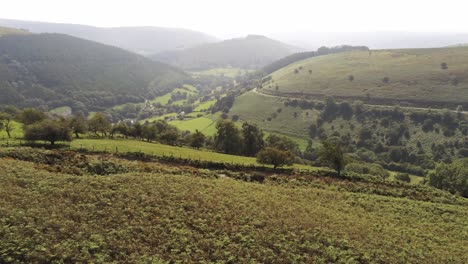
left=263, top=47, right=468, bottom=104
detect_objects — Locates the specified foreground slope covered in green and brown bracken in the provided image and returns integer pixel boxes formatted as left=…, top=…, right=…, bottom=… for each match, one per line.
left=0, top=149, right=468, bottom=263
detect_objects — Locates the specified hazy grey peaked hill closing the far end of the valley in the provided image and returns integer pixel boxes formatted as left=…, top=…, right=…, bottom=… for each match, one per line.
left=151, top=35, right=299, bottom=70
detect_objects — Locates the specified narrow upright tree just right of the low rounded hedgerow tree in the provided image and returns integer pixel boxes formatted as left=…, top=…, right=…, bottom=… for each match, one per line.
left=318, top=139, right=345, bottom=176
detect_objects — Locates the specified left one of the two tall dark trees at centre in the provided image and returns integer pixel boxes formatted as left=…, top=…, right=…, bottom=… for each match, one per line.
left=214, top=120, right=242, bottom=154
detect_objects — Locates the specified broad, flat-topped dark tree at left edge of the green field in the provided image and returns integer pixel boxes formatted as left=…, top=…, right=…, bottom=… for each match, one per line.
left=24, top=120, right=71, bottom=145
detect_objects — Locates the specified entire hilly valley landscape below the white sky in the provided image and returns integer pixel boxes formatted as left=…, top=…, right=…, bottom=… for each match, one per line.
left=0, top=13, right=468, bottom=263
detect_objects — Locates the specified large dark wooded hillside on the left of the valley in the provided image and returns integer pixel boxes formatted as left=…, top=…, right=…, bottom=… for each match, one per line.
left=0, top=34, right=188, bottom=112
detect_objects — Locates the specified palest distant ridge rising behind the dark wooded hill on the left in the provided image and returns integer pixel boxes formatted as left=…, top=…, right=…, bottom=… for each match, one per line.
left=0, top=19, right=216, bottom=55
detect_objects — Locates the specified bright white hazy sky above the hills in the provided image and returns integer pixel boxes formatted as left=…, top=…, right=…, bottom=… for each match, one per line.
left=0, top=0, right=468, bottom=37
